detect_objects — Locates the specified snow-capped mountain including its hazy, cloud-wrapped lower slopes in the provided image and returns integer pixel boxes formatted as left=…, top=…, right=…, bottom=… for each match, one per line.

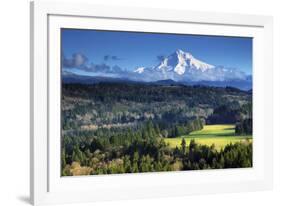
left=134, top=49, right=247, bottom=82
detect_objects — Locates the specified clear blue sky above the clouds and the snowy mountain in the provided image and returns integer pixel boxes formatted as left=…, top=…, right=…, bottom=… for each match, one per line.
left=61, top=29, right=252, bottom=74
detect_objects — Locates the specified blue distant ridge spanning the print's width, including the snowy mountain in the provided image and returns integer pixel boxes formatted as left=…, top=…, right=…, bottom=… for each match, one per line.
left=62, top=49, right=252, bottom=90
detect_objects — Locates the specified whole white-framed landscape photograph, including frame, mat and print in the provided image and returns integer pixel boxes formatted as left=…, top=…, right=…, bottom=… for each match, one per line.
left=31, top=1, right=273, bottom=205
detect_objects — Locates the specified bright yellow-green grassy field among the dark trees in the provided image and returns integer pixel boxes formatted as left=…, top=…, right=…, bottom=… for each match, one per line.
left=165, top=125, right=252, bottom=150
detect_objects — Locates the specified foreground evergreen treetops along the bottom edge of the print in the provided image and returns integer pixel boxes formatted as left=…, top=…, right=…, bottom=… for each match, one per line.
left=62, top=139, right=252, bottom=176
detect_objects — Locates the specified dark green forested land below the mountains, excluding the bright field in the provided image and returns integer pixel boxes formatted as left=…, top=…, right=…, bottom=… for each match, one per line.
left=61, top=82, right=252, bottom=175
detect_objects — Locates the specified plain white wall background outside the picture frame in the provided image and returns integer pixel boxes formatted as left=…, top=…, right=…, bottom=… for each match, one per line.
left=0, top=0, right=281, bottom=206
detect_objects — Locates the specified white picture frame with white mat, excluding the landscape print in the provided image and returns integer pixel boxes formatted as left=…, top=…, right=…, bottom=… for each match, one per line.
left=30, top=1, right=273, bottom=205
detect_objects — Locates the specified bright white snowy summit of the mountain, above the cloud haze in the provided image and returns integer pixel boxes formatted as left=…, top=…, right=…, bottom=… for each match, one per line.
left=156, top=49, right=214, bottom=75
